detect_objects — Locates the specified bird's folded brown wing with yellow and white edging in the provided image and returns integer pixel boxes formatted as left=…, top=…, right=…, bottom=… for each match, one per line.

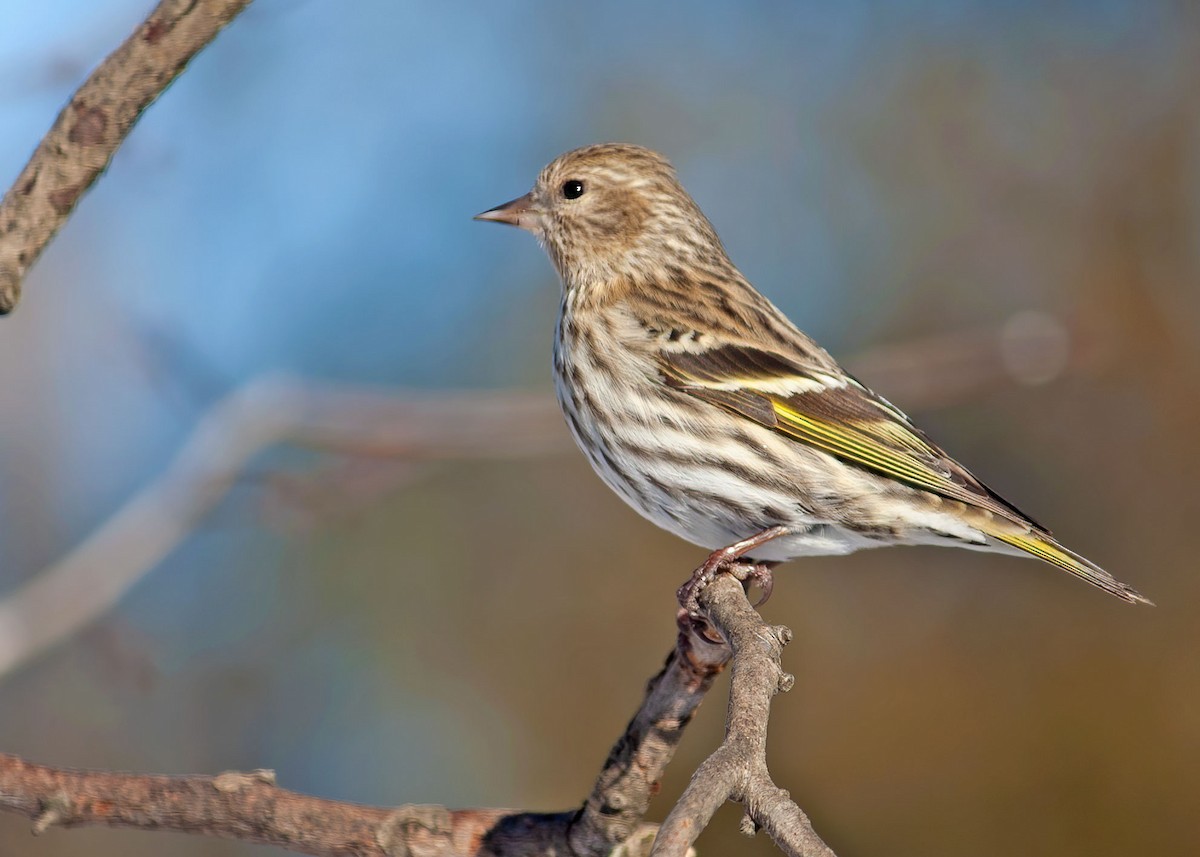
left=659, top=344, right=1048, bottom=534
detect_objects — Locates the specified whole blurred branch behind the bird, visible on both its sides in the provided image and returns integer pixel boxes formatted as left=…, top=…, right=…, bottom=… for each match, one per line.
left=0, top=316, right=1093, bottom=681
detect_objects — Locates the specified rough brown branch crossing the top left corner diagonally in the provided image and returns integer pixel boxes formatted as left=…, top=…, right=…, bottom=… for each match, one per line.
left=0, top=0, right=250, bottom=314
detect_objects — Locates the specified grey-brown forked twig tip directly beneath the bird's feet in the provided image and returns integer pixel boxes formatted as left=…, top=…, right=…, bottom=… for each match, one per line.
left=650, top=575, right=834, bottom=857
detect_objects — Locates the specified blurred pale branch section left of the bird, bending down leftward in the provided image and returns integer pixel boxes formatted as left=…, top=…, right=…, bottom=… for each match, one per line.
left=0, top=378, right=570, bottom=677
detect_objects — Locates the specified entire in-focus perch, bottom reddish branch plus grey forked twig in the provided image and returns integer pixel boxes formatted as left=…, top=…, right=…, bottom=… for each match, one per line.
left=0, top=575, right=833, bottom=857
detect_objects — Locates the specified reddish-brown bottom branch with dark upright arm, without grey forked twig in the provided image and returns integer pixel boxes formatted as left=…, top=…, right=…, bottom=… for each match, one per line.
left=0, top=609, right=730, bottom=857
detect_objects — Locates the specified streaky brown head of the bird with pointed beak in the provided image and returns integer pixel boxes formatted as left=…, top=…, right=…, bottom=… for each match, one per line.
left=476, top=143, right=726, bottom=290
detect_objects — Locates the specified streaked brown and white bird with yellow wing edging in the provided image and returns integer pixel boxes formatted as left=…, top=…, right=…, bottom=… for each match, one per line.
left=475, top=143, right=1151, bottom=607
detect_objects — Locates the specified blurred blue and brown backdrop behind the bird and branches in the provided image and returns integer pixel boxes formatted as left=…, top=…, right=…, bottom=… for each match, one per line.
left=0, top=0, right=1200, bottom=857
